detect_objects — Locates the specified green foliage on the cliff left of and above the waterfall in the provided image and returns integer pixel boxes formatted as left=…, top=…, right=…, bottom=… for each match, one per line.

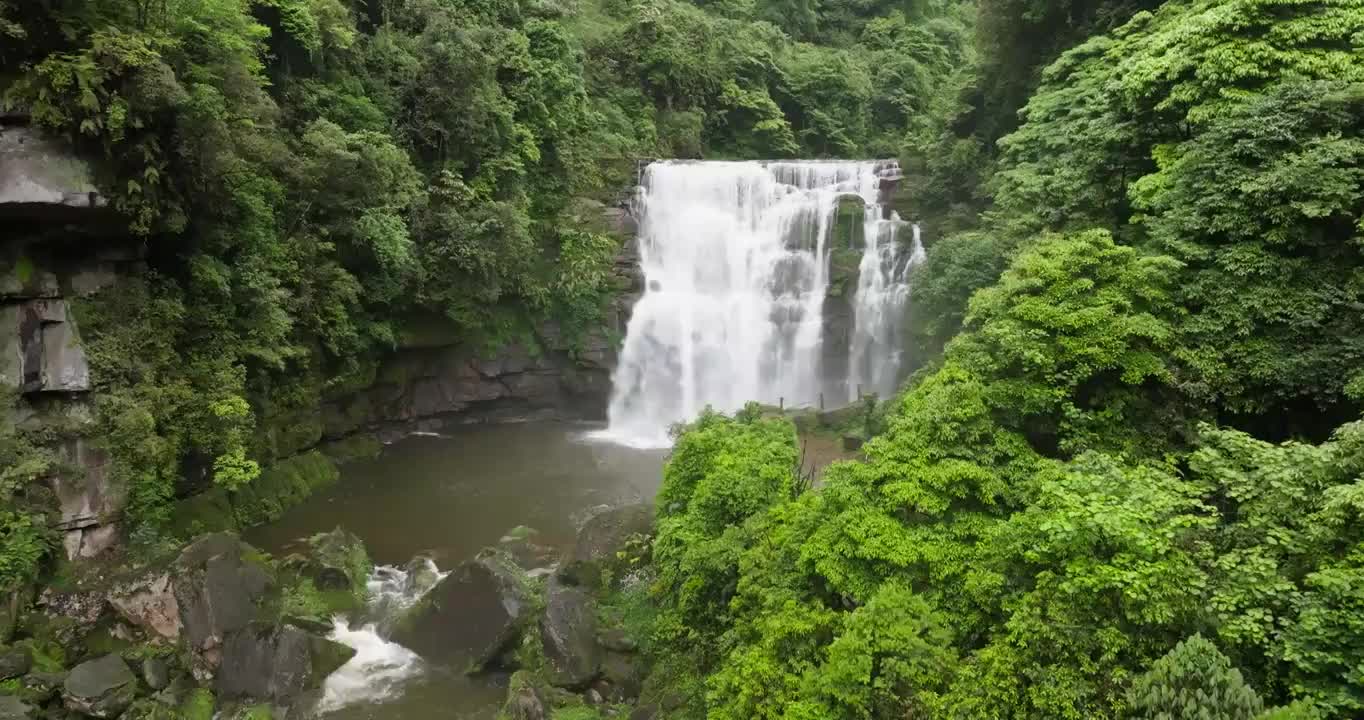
left=0, top=0, right=971, bottom=540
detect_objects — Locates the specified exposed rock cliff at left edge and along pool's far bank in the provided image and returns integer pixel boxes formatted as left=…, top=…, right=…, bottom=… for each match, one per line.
left=0, top=120, right=638, bottom=559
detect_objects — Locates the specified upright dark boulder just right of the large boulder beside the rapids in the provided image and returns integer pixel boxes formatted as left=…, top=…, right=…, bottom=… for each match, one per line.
left=540, top=580, right=602, bottom=687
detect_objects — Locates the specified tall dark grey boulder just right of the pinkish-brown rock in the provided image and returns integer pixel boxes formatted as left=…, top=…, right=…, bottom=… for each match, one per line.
left=173, top=533, right=271, bottom=680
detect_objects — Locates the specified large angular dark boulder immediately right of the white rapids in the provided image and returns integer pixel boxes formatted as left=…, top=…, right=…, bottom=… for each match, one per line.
left=393, top=550, right=535, bottom=671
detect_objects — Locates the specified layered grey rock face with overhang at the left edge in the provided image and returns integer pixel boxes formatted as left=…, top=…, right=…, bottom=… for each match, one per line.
left=0, top=117, right=132, bottom=558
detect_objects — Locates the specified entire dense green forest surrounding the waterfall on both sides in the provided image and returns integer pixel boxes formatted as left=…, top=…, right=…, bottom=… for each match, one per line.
left=0, top=0, right=1364, bottom=720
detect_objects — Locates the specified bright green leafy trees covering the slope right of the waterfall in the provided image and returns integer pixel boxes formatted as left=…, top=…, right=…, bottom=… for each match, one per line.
left=635, top=0, right=1364, bottom=719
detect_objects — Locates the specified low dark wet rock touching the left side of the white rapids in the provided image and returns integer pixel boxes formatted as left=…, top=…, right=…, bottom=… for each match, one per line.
left=216, top=623, right=355, bottom=702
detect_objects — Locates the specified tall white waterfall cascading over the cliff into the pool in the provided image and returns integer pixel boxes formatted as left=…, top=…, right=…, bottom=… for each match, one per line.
left=603, top=161, right=922, bottom=446
